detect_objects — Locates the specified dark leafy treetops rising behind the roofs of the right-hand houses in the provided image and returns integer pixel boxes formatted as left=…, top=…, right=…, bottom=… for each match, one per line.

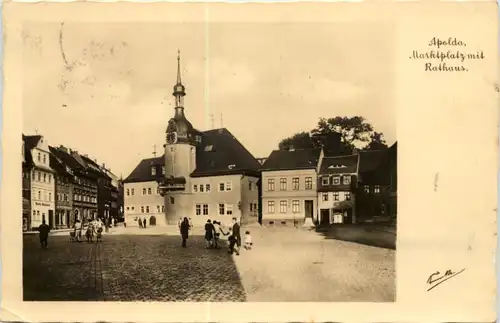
left=279, top=116, right=387, bottom=152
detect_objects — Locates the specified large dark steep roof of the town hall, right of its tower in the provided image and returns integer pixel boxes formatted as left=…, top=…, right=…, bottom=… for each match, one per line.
left=191, top=128, right=261, bottom=177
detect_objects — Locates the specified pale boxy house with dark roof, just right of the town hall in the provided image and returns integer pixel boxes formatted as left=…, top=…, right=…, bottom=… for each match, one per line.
left=261, top=149, right=323, bottom=225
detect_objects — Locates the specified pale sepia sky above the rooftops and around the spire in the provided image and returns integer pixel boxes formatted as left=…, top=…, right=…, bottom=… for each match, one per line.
left=22, top=23, right=396, bottom=177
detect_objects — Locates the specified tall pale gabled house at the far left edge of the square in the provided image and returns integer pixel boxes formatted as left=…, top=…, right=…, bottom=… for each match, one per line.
left=24, top=135, right=55, bottom=229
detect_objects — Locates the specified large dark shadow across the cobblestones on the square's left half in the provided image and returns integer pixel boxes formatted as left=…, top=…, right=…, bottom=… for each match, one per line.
left=23, top=235, right=246, bottom=302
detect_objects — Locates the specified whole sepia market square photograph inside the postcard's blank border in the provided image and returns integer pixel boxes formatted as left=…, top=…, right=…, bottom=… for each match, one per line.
left=22, top=18, right=397, bottom=302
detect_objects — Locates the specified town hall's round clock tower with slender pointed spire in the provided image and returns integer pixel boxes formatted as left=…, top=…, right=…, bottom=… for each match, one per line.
left=160, top=52, right=196, bottom=224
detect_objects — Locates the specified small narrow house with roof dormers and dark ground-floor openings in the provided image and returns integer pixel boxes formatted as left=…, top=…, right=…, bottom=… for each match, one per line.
left=318, top=154, right=359, bottom=225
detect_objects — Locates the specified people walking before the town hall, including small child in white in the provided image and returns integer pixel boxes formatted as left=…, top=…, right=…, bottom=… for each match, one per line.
left=179, top=217, right=252, bottom=255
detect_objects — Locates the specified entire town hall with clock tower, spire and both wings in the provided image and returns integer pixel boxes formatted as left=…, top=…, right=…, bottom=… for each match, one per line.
left=124, top=51, right=261, bottom=225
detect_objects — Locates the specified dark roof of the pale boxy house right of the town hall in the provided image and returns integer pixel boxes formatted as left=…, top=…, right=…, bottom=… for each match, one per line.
left=262, top=148, right=321, bottom=170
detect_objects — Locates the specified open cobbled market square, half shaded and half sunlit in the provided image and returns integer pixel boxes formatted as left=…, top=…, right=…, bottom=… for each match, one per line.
left=24, top=228, right=395, bottom=302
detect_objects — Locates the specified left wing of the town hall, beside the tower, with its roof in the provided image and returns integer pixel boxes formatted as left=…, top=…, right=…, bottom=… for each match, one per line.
left=123, top=157, right=167, bottom=226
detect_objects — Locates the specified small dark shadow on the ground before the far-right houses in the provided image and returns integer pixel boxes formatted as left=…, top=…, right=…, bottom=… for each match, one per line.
left=316, top=224, right=397, bottom=250
